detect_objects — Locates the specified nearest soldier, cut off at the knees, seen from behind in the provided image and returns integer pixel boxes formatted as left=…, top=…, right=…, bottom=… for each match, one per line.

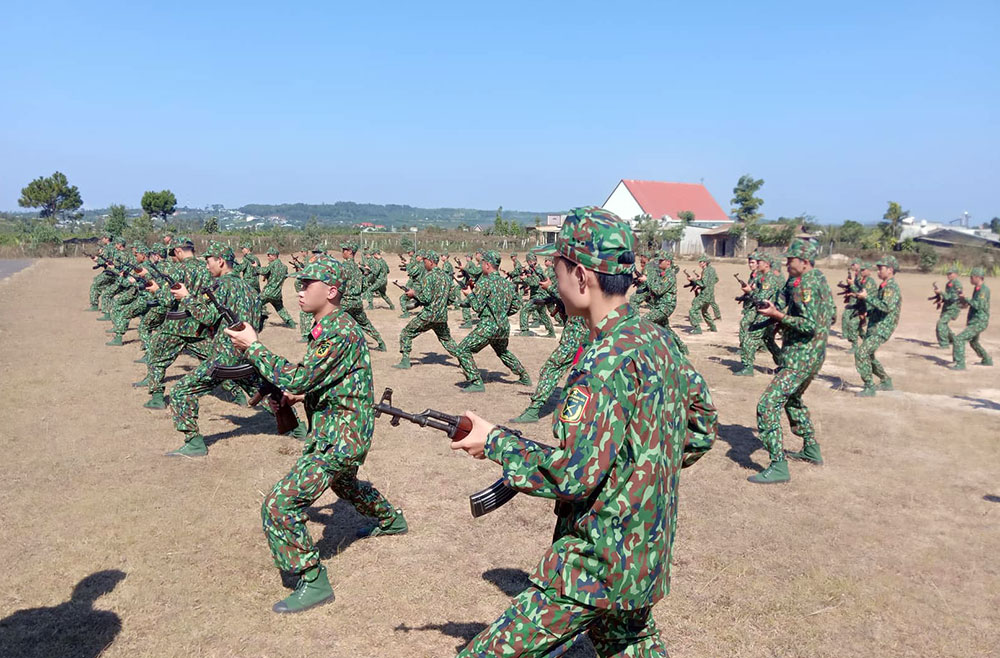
left=452, top=207, right=718, bottom=658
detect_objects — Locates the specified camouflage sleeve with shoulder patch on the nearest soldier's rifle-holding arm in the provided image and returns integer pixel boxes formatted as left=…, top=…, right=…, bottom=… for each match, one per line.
left=485, top=373, right=625, bottom=501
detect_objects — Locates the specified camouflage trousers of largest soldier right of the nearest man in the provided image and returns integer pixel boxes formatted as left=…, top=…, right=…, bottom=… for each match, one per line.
left=757, top=368, right=816, bottom=462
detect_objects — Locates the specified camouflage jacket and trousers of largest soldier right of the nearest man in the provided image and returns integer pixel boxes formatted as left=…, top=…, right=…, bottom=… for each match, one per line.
left=757, top=268, right=836, bottom=462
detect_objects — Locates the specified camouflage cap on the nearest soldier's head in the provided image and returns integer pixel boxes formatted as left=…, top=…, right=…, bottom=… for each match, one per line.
left=538, top=206, right=635, bottom=274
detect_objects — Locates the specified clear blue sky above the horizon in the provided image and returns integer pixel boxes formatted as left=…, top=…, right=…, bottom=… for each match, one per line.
left=0, top=0, right=1000, bottom=223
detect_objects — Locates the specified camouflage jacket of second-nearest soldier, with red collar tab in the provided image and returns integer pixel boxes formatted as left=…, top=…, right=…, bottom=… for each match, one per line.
left=246, top=309, right=375, bottom=458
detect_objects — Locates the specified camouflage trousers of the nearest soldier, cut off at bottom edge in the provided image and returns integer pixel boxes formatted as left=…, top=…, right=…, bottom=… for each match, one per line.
left=458, top=585, right=667, bottom=658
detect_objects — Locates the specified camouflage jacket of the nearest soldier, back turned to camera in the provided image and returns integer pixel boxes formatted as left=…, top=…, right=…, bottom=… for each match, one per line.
left=486, top=304, right=718, bottom=610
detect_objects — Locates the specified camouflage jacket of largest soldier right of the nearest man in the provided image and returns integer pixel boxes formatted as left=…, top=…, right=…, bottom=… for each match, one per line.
left=777, top=268, right=836, bottom=372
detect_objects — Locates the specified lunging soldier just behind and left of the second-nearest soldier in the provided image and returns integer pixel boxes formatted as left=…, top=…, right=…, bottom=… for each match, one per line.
left=167, top=242, right=294, bottom=457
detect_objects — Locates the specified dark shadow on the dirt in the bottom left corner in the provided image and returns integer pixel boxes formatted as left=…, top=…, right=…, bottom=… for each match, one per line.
left=0, top=569, right=125, bottom=658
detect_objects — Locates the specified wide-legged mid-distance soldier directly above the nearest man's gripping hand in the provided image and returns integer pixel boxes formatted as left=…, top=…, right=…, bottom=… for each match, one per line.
left=458, top=251, right=531, bottom=393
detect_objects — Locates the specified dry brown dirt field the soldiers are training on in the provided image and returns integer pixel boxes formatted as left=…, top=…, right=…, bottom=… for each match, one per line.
left=0, top=258, right=1000, bottom=658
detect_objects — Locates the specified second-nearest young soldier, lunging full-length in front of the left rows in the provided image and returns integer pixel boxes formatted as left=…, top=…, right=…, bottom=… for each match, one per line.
left=225, top=258, right=407, bottom=613
